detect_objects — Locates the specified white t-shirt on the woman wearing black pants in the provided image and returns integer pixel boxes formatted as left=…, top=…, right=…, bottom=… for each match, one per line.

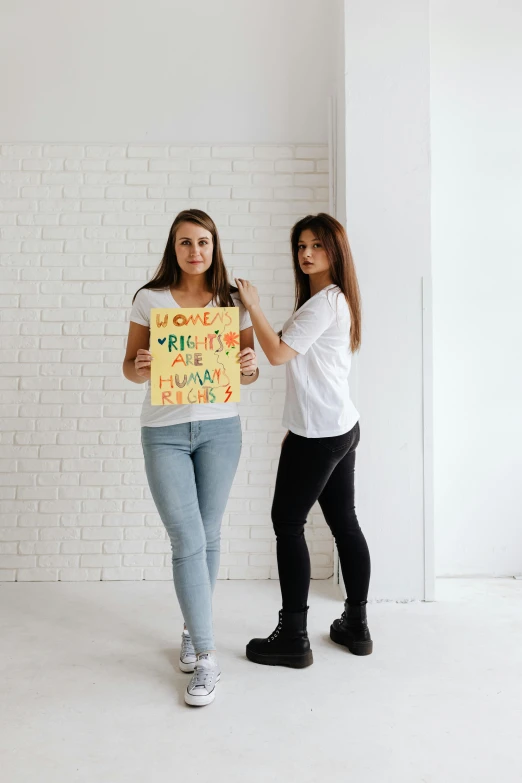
left=281, top=285, right=359, bottom=438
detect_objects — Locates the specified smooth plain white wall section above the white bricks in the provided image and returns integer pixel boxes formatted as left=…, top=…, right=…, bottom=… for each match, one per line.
left=0, top=0, right=342, bottom=144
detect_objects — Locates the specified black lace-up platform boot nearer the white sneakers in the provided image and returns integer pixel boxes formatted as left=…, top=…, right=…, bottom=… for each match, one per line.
left=247, top=608, right=314, bottom=669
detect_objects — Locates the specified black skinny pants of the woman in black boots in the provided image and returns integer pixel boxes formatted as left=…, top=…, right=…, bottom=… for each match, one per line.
left=272, top=423, right=370, bottom=612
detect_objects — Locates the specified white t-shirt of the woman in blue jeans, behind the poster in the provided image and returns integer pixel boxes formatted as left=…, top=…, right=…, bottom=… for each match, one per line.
left=130, top=288, right=252, bottom=427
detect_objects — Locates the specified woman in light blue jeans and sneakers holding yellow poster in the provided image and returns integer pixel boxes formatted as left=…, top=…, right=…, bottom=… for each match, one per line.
left=123, top=209, right=259, bottom=705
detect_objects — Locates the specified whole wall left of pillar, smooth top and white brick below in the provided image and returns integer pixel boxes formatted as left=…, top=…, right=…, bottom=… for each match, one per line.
left=0, top=0, right=350, bottom=580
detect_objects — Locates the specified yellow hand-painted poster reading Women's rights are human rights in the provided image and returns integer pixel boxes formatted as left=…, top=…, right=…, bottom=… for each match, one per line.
left=150, top=307, right=240, bottom=405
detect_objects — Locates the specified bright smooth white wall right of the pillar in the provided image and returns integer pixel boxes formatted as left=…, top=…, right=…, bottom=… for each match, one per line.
left=431, top=0, right=522, bottom=575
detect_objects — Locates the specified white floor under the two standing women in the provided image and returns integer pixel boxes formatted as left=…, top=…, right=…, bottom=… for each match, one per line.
left=0, top=579, right=522, bottom=783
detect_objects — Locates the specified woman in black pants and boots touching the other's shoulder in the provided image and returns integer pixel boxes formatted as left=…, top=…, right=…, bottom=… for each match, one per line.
left=237, top=213, right=373, bottom=668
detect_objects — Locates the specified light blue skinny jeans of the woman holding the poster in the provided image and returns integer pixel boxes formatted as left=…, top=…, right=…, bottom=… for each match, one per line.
left=141, top=416, right=241, bottom=652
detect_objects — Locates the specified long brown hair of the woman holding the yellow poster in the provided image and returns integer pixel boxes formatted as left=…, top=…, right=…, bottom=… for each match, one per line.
left=132, top=209, right=237, bottom=307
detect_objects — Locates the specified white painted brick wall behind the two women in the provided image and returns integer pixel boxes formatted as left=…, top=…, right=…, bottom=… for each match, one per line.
left=0, top=143, right=333, bottom=581
